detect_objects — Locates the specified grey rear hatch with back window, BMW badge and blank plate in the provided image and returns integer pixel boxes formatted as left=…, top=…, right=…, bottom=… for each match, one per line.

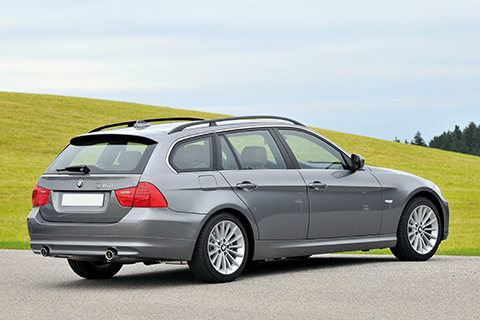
left=38, top=134, right=156, bottom=223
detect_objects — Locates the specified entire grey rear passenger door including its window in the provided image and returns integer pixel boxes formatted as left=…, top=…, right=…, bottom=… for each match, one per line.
left=220, top=129, right=309, bottom=240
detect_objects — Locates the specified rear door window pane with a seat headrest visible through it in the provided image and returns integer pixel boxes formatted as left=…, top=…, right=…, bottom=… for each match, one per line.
left=222, top=130, right=287, bottom=169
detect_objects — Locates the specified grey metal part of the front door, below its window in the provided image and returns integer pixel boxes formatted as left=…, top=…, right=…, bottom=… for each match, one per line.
left=300, top=170, right=382, bottom=239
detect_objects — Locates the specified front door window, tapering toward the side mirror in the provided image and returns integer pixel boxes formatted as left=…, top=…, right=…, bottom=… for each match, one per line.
left=279, top=130, right=347, bottom=170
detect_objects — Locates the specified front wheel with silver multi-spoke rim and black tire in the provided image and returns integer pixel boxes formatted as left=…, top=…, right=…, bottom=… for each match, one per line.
left=390, top=198, right=442, bottom=261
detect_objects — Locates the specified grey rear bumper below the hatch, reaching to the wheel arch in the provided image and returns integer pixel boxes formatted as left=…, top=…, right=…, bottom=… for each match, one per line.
left=27, top=207, right=207, bottom=263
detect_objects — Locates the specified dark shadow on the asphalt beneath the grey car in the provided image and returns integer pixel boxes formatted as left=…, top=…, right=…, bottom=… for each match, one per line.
left=55, top=254, right=398, bottom=290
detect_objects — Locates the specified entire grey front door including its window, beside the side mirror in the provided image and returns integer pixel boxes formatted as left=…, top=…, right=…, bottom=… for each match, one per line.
left=279, top=129, right=382, bottom=239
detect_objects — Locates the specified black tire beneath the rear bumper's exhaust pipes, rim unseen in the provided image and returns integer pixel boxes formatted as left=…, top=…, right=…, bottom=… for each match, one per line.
left=68, top=259, right=123, bottom=279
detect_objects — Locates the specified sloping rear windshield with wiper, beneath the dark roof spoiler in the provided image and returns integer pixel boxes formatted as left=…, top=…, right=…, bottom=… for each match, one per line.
left=46, top=135, right=155, bottom=173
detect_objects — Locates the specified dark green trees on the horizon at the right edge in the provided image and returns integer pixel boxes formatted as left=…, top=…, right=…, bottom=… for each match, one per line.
left=394, top=122, right=480, bottom=156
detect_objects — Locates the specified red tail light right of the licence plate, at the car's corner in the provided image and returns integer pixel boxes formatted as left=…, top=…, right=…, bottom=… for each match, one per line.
left=115, top=182, right=168, bottom=208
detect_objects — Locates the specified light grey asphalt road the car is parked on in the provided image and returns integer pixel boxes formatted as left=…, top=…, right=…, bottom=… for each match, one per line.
left=0, top=250, right=480, bottom=320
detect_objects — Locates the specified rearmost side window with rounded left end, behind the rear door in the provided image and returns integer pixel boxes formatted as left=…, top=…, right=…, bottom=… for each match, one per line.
left=170, top=137, right=213, bottom=172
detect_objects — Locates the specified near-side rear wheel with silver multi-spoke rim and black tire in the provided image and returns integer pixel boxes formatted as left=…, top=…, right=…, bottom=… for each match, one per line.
left=188, top=213, right=249, bottom=283
